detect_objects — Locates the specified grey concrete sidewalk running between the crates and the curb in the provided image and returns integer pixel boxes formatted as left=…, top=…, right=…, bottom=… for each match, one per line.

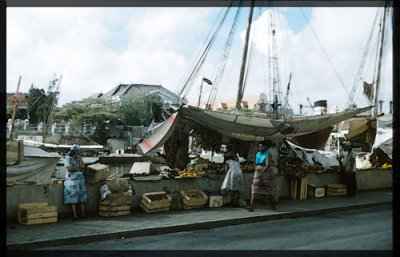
left=6, top=189, right=393, bottom=250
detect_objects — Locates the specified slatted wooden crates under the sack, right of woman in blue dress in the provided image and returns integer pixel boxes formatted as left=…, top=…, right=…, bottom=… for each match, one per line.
left=99, top=193, right=132, bottom=217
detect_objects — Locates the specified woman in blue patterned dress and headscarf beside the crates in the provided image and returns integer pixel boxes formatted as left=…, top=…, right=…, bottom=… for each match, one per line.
left=64, top=145, right=88, bottom=220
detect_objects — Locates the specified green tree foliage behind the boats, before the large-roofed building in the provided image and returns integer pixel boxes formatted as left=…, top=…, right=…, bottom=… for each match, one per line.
left=15, top=84, right=159, bottom=141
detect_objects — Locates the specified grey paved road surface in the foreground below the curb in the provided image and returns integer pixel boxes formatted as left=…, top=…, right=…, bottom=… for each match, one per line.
left=41, top=207, right=393, bottom=250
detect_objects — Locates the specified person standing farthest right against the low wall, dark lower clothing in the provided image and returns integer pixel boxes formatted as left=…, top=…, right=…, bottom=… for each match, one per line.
left=339, top=141, right=357, bottom=196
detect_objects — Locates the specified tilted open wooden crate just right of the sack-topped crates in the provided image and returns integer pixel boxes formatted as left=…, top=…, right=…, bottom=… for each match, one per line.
left=140, top=191, right=172, bottom=213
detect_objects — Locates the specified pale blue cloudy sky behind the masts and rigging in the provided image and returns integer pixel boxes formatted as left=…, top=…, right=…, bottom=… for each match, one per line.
left=6, top=7, right=392, bottom=113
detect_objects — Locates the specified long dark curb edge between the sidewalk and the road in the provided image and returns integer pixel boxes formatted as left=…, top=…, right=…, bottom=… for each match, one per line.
left=7, top=201, right=393, bottom=250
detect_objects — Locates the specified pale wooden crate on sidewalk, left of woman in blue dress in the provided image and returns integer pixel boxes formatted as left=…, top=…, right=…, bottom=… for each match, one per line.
left=18, top=202, right=58, bottom=225
